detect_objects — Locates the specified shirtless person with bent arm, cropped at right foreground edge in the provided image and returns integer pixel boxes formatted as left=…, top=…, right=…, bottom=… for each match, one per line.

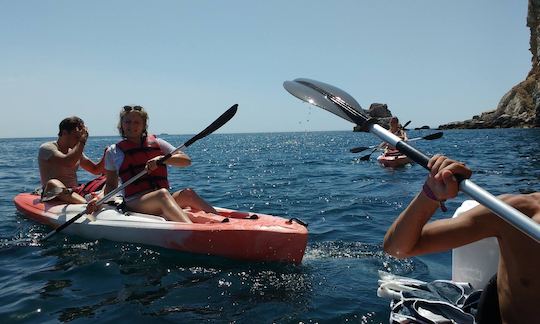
left=384, top=155, right=540, bottom=323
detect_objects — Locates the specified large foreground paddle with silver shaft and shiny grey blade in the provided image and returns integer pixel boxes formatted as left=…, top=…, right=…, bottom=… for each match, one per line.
left=283, top=78, right=540, bottom=243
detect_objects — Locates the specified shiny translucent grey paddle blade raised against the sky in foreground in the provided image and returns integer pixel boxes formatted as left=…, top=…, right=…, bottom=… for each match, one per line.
left=283, top=78, right=367, bottom=125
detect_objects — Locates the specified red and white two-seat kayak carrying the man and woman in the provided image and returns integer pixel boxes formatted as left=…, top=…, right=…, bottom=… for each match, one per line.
left=14, top=193, right=308, bottom=264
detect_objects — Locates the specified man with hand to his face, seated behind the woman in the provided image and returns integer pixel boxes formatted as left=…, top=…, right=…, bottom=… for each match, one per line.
left=38, top=116, right=105, bottom=204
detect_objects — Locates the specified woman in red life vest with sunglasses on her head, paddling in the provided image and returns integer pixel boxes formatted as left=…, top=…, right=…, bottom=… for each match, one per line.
left=96, top=106, right=217, bottom=223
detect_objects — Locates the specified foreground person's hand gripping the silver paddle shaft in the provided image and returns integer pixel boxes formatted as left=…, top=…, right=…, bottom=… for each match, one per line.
left=426, top=154, right=472, bottom=200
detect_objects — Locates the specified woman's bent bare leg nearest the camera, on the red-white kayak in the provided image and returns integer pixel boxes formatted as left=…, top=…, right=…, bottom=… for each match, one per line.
left=126, top=189, right=192, bottom=223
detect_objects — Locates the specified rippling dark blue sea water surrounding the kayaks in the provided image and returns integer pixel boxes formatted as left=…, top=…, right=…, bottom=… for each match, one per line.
left=0, top=129, right=540, bottom=323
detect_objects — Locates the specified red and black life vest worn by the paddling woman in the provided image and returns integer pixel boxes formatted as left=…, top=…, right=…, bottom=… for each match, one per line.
left=116, top=135, right=169, bottom=197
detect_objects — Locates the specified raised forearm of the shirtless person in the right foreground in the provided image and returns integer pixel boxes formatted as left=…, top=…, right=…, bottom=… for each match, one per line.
left=384, top=193, right=439, bottom=258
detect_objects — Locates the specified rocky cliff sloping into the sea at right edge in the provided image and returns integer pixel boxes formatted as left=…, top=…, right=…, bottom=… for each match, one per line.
left=439, top=0, right=540, bottom=129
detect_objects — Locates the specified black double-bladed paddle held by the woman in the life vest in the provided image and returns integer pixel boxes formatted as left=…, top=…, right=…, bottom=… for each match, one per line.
left=42, top=104, right=238, bottom=240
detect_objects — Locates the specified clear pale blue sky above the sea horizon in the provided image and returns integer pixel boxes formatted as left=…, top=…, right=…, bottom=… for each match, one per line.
left=0, top=0, right=531, bottom=138
